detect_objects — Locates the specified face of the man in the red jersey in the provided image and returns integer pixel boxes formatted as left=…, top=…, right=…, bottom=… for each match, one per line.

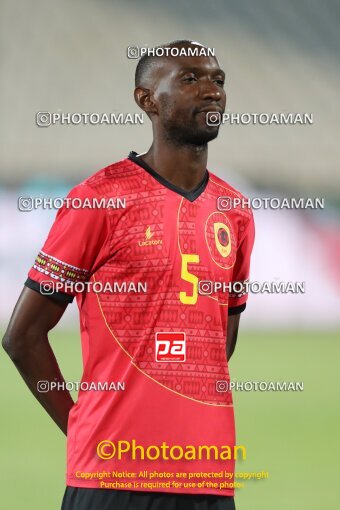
left=153, top=57, right=226, bottom=146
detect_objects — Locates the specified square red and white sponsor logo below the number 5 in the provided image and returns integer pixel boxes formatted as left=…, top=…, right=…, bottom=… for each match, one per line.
left=155, top=332, right=186, bottom=363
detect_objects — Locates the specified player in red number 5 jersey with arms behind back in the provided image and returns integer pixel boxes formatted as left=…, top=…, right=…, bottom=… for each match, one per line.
left=3, top=41, right=254, bottom=510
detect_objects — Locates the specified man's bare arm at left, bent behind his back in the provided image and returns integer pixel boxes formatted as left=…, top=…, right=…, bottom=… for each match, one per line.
left=2, top=287, right=74, bottom=435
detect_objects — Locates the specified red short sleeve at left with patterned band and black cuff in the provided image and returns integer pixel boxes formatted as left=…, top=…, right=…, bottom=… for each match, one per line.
left=25, top=183, right=108, bottom=303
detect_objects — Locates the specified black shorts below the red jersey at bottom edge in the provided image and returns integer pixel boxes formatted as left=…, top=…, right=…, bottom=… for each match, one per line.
left=61, top=487, right=235, bottom=510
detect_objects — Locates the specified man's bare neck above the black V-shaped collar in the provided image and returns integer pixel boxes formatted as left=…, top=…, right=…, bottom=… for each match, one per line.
left=140, top=140, right=208, bottom=191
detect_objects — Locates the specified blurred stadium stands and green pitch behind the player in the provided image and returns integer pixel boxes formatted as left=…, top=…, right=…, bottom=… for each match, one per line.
left=0, top=0, right=340, bottom=510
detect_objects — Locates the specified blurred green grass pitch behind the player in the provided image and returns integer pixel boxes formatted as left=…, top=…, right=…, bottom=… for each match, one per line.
left=0, top=329, right=340, bottom=510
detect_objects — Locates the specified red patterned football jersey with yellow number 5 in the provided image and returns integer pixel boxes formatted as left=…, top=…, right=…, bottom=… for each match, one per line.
left=26, top=152, right=254, bottom=495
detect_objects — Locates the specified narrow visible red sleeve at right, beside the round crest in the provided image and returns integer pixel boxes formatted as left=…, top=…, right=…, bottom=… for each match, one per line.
left=228, top=210, right=255, bottom=315
